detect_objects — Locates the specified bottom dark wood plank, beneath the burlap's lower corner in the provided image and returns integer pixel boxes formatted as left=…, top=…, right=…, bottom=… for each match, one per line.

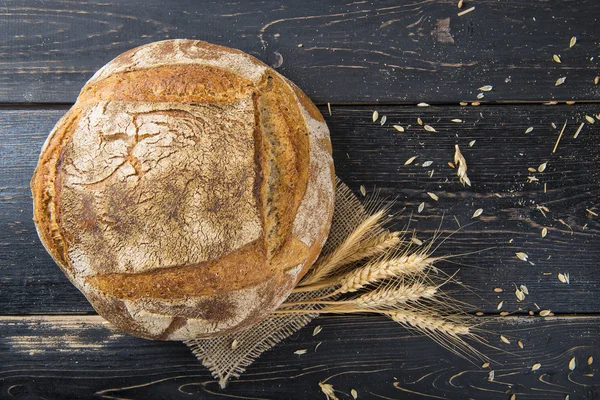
left=0, top=316, right=600, bottom=400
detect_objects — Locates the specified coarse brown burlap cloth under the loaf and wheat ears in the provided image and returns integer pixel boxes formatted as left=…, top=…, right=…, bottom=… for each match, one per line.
left=185, top=178, right=368, bottom=388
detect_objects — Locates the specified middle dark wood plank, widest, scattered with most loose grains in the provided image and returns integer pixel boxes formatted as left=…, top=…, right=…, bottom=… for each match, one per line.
left=0, top=105, right=600, bottom=315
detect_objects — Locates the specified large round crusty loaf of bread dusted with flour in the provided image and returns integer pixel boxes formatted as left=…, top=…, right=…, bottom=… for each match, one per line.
left=31, top=40, right=334, bottom=340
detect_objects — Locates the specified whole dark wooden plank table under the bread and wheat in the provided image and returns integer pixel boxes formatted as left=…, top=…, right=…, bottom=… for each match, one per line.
left=0, top=0, right=600, bottom=399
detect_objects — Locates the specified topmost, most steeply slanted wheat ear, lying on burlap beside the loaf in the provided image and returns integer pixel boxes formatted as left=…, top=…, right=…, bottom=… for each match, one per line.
left=298, top=209, right=386, bottom=286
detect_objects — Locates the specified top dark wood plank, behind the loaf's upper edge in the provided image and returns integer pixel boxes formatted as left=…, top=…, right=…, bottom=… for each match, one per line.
left=0, top=0, right=600, bottom=103
